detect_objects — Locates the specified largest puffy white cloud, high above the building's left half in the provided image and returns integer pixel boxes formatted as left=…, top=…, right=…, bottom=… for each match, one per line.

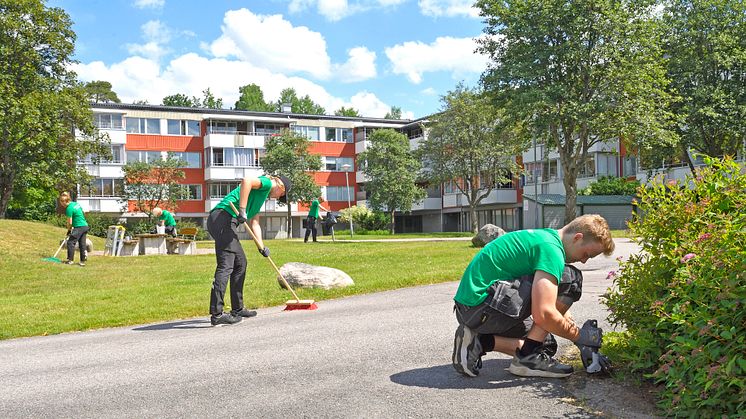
left=210, top=9, right=331, bottom=79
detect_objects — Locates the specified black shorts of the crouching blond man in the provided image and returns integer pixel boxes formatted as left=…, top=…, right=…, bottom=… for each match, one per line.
left=454, top=265, right=583, bottom=338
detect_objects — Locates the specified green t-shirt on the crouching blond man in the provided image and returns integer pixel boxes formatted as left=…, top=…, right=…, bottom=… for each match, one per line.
left=453, top=228, right=565, bottom=306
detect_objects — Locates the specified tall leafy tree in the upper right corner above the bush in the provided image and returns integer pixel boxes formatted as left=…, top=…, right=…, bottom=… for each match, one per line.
left=664, top=0, right=746, bottom=171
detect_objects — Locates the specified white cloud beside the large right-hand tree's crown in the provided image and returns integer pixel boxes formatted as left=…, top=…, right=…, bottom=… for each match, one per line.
left=386, top=37, right=487, bottom=84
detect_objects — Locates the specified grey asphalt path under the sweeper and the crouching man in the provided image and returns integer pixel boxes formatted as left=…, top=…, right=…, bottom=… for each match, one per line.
left=0, top=240, right=635, bottom=418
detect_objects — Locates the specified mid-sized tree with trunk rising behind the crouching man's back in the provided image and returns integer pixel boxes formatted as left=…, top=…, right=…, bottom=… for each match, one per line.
left=418, top=84, right=526, bottom=234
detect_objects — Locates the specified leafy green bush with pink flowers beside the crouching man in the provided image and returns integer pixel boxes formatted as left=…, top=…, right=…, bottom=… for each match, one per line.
left=605, top=158, right=746, bottom=417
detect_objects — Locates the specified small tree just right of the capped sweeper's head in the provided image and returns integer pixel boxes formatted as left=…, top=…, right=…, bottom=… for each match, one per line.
left=260, top=130, right=321, bottom=237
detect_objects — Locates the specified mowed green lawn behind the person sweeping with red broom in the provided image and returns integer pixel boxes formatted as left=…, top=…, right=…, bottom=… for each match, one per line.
left=0, top=220, right=479, bottom=339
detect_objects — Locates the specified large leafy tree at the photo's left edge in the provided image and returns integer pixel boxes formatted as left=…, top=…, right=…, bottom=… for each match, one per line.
left=0, top=0, right=111, bottom=218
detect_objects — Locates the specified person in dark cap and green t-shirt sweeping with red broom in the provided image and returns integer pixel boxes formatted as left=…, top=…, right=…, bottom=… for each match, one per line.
left=207, top=176, right=292, bottom=326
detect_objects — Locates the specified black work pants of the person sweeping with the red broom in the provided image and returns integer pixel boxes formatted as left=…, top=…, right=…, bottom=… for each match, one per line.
left=207, top=209, right=246, bottom=315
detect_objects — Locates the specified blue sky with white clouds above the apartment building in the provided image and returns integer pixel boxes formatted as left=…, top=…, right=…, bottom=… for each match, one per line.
left=48, top=0, right=487, bottom=119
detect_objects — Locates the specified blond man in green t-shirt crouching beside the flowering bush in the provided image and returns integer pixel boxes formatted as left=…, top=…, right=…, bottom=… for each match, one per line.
left=452, top=214, right=614, bottom=377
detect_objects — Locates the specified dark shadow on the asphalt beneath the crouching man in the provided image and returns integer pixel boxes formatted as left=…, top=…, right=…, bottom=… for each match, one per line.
left=390, top=359, right=565, bottom=396
